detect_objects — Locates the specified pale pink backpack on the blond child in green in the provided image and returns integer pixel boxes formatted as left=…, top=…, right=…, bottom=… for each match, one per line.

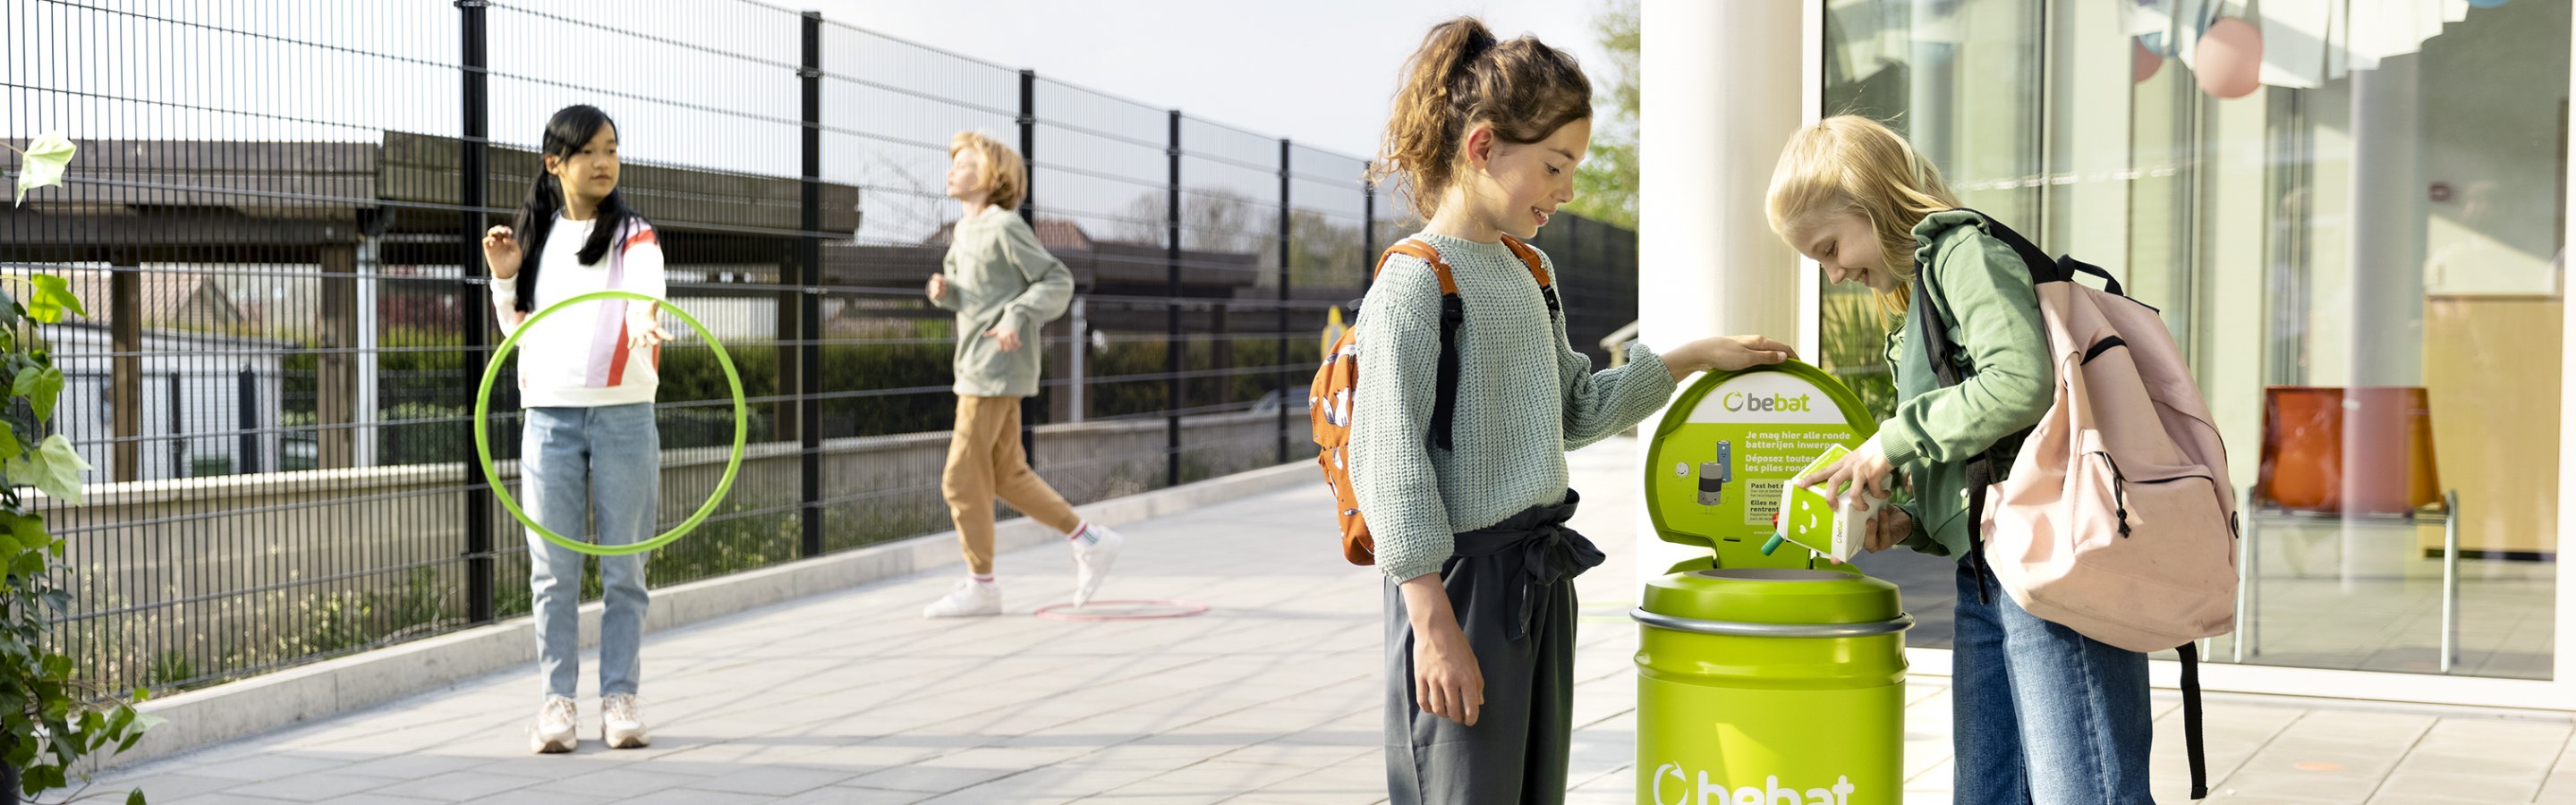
left=1917, top=214, right=2236, bottom=800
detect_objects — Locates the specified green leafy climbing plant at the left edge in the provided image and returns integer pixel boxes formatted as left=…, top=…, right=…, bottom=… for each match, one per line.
left=0, top=131, right=162, bottom=805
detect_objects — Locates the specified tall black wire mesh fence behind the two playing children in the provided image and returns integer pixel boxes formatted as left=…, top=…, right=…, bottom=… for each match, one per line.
left=0, top=0, right=1636, bottom=690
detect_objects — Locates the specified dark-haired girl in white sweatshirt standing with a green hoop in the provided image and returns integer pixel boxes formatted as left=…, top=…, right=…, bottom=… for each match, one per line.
left=484, top=106, right=670, bottom=753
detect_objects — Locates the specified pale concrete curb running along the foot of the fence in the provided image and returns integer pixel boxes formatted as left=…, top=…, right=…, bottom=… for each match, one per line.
left=103, top=463, right=1316, bottom=767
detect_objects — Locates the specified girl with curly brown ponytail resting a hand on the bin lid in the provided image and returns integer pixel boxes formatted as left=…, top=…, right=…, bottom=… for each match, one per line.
left=1350, top=18, right=1793, bottom=805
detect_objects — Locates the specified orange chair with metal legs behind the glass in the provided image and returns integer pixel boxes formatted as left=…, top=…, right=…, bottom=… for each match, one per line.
left=2236, top=386, right=2460, bottom=674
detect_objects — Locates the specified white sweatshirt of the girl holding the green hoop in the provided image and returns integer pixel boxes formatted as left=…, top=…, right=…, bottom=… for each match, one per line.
left=492, top=216, right=667, bottom=409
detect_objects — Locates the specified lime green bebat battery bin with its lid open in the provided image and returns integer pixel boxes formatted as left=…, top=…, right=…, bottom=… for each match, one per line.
left=1633, top=362, right=1914, bottom=805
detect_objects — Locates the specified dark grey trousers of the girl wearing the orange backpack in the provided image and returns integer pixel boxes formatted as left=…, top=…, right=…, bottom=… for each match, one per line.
left=1386, top=491, right=1603, bottom=805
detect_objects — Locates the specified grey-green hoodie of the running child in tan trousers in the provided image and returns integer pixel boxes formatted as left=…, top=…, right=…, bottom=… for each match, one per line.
left=932, top=208, right=1075, bottom=396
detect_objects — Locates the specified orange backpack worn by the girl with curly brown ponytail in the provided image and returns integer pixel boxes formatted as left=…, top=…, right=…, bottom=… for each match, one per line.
left=1306, top=234, right=1564, bottom=566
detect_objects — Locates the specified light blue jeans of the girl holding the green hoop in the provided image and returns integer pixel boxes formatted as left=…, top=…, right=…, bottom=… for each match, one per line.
left=518, top=403, right=662, bottom=697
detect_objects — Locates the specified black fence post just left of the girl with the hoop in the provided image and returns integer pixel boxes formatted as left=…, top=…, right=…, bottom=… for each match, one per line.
left=456, top=0, right=500, bottom=623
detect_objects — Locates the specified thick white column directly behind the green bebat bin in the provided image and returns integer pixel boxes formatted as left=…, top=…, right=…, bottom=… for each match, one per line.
left=1630, top=0, right=1824, bottom=584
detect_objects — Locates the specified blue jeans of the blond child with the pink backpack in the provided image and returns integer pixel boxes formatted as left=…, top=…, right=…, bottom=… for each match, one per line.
left=1950, top=561, right=2156, bottom=805
